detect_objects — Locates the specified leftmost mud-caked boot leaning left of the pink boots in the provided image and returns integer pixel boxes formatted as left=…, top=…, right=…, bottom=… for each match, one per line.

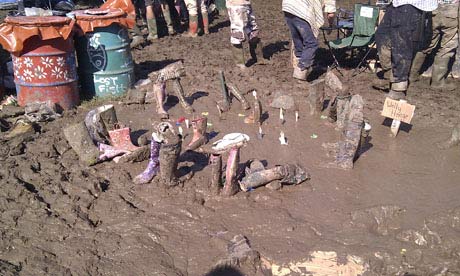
left=64, top=122, right=99, bottom=166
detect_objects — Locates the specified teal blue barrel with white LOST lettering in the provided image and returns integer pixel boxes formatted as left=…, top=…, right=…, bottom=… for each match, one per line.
left=76, top=10, right=134, bottom=98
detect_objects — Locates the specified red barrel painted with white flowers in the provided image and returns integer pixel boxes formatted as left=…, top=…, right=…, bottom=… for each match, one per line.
left=9, top=16, right=80, bottom=109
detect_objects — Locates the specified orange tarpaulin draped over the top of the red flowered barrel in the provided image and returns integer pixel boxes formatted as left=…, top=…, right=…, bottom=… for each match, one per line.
left=0, top=16, right=75, bottom=54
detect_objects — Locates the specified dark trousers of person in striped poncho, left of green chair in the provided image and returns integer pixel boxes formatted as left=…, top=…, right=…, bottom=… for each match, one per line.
left=284, top=12, right=318, bottom=70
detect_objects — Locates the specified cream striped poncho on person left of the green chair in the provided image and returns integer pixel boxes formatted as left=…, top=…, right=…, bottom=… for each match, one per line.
left=282, top=0, right=336, bottom=37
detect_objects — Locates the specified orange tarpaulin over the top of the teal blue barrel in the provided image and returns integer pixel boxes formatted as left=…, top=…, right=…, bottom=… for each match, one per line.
left=73, top=7, right=134, bottom=34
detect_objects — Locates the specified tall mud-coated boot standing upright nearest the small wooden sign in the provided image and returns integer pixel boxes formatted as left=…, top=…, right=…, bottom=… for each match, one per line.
left=326, top=95, right=364, bottom=170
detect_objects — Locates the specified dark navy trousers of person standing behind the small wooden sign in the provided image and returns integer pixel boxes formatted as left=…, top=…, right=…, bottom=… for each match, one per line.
left=375, top=5, right=423, bottom=82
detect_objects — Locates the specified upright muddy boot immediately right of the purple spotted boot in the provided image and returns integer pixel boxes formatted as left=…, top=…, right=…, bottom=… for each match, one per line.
left=160, top=126, right=182, bottom=187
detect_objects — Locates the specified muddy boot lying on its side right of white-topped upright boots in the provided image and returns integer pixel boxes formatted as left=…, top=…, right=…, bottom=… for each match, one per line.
left=240, top=164, right=310, bottom=192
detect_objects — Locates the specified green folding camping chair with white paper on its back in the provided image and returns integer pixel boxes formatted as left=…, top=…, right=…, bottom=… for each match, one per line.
left=323, top=4, right=379, bottom=76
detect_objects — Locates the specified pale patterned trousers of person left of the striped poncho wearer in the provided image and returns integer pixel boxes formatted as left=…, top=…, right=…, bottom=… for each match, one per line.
left=227, top=5, right=259, bottom=45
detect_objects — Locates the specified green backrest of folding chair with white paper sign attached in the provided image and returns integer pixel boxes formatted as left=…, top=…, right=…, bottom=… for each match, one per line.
left=353, top=4, right=379, bottom=36
